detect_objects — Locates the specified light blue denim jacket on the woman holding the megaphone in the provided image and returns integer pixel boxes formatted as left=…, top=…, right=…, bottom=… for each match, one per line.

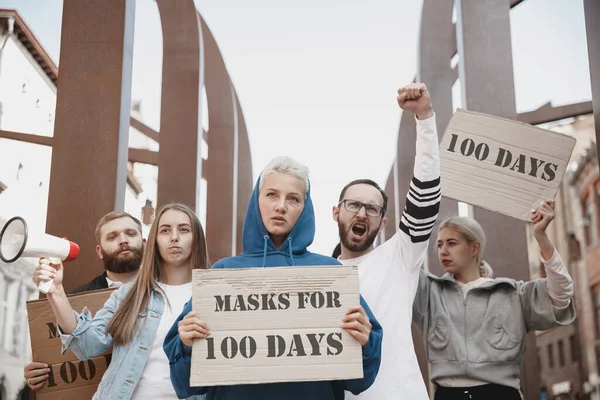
left=61, top=283, right=204, bottom=400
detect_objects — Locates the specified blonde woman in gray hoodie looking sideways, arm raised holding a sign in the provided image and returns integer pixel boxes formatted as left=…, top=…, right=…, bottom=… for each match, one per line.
left=413, top=201, right=575, bottom=400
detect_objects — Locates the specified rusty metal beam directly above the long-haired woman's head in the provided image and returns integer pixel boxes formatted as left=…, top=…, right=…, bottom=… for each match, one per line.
left=156, top=0, right=202, bottom=211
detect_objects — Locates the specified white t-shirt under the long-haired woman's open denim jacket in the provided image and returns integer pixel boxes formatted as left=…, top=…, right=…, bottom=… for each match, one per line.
left=131, top=282, right=192, bottom=400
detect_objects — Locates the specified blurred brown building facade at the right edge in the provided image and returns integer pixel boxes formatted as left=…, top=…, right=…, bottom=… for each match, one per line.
left=527, top=115, right=600, bottom=400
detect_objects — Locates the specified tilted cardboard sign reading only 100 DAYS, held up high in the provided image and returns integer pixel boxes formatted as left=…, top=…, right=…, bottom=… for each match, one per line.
left=440, top=109, right=575, bottom=221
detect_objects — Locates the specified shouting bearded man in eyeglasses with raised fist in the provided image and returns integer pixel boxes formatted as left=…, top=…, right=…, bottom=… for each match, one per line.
left=333, top=83, right=441, bottom=400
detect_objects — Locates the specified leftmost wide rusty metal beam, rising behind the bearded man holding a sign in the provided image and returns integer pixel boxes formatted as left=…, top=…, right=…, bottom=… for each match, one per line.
left=46, top=0, right=135, bottom=291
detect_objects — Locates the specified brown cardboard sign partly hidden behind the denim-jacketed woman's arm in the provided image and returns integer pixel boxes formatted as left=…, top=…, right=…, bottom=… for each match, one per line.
left=27, top=289, right=114, bottom=400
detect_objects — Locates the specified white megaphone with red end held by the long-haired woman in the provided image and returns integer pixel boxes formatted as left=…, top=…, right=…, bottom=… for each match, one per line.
left=0, top=217, right=79, bottom=293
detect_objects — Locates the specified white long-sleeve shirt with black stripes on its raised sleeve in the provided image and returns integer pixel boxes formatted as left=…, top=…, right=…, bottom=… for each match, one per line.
left=341, top=116, right=441, bottom=400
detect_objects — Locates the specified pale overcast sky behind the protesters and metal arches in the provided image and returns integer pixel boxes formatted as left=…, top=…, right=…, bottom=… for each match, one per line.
left=0, top=0, right=591, bottom=253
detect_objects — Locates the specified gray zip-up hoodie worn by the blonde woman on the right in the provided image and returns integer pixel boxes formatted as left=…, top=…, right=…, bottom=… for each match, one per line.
left=413, top=271, right=575, bottom=389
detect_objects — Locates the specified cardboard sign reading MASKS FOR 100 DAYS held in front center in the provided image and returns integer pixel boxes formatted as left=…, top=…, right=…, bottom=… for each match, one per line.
left=190, top=266, right=363, bottom=386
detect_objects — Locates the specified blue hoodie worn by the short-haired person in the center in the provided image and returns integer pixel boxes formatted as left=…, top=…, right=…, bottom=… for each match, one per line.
left=164, top=177, right=383, bottom=400
